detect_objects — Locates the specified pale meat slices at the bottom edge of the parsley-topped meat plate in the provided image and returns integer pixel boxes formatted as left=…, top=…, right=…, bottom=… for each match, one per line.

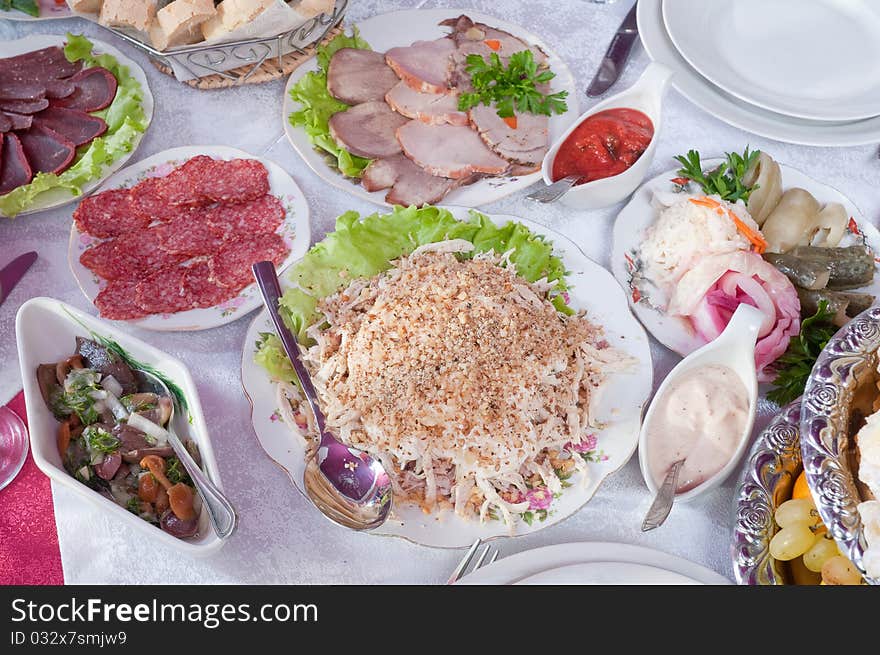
left=361, top=154, right=458, bottom=206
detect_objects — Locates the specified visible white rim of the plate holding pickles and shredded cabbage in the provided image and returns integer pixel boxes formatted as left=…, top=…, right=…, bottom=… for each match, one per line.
left=611, top=159, right=880, bottom=356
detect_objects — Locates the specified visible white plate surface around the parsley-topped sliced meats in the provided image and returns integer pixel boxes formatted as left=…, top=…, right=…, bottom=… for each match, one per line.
left=281, top=9, right=580, bottom=207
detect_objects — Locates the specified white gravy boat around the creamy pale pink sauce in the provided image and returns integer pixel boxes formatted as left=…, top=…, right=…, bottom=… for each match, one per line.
left=639, top=303, right=764, bottom=502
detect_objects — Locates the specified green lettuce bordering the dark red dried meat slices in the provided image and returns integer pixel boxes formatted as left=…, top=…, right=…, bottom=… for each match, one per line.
left=0, top=34, right=147, bottom=216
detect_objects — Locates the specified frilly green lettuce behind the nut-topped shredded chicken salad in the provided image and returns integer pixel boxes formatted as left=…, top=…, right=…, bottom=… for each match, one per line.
left=254, top=206, right=574, bottom=382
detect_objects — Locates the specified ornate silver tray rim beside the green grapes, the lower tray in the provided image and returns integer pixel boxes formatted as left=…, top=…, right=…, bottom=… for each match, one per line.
left=732, top=399, right=801, bottom=585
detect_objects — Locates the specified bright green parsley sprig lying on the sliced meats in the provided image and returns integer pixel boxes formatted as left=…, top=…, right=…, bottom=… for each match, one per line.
left=458, top=50, right=568, bottom=118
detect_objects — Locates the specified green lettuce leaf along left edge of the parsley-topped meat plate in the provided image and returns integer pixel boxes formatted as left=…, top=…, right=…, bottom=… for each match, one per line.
left=288, top=28, right=370, bottom=177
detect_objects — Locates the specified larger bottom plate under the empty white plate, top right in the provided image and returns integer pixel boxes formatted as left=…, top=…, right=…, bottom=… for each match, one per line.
left=636, top=0, right=880, bottom=147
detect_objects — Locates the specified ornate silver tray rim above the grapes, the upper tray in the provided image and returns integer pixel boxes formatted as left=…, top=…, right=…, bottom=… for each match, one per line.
left=800, top=307, right=880, bottom=584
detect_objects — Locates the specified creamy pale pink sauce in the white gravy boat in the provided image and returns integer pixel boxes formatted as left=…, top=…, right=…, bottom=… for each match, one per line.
left=646, top=364, right=749, bottom=493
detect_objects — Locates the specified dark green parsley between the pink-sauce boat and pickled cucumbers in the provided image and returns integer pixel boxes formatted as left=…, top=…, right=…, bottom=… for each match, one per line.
left=767, top=300, right=837, bottom=406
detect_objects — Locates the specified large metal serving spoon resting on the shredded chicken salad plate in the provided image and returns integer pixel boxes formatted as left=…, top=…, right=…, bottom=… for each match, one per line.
left=253, top=262, right=392, bottom=530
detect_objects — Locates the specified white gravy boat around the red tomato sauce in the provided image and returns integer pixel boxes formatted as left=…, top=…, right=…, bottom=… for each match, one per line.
left=541, top=62, right=672, bottom=209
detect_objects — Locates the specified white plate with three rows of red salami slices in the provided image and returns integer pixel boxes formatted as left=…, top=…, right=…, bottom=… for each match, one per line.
left=68, top=146, right=310, bottom=331
